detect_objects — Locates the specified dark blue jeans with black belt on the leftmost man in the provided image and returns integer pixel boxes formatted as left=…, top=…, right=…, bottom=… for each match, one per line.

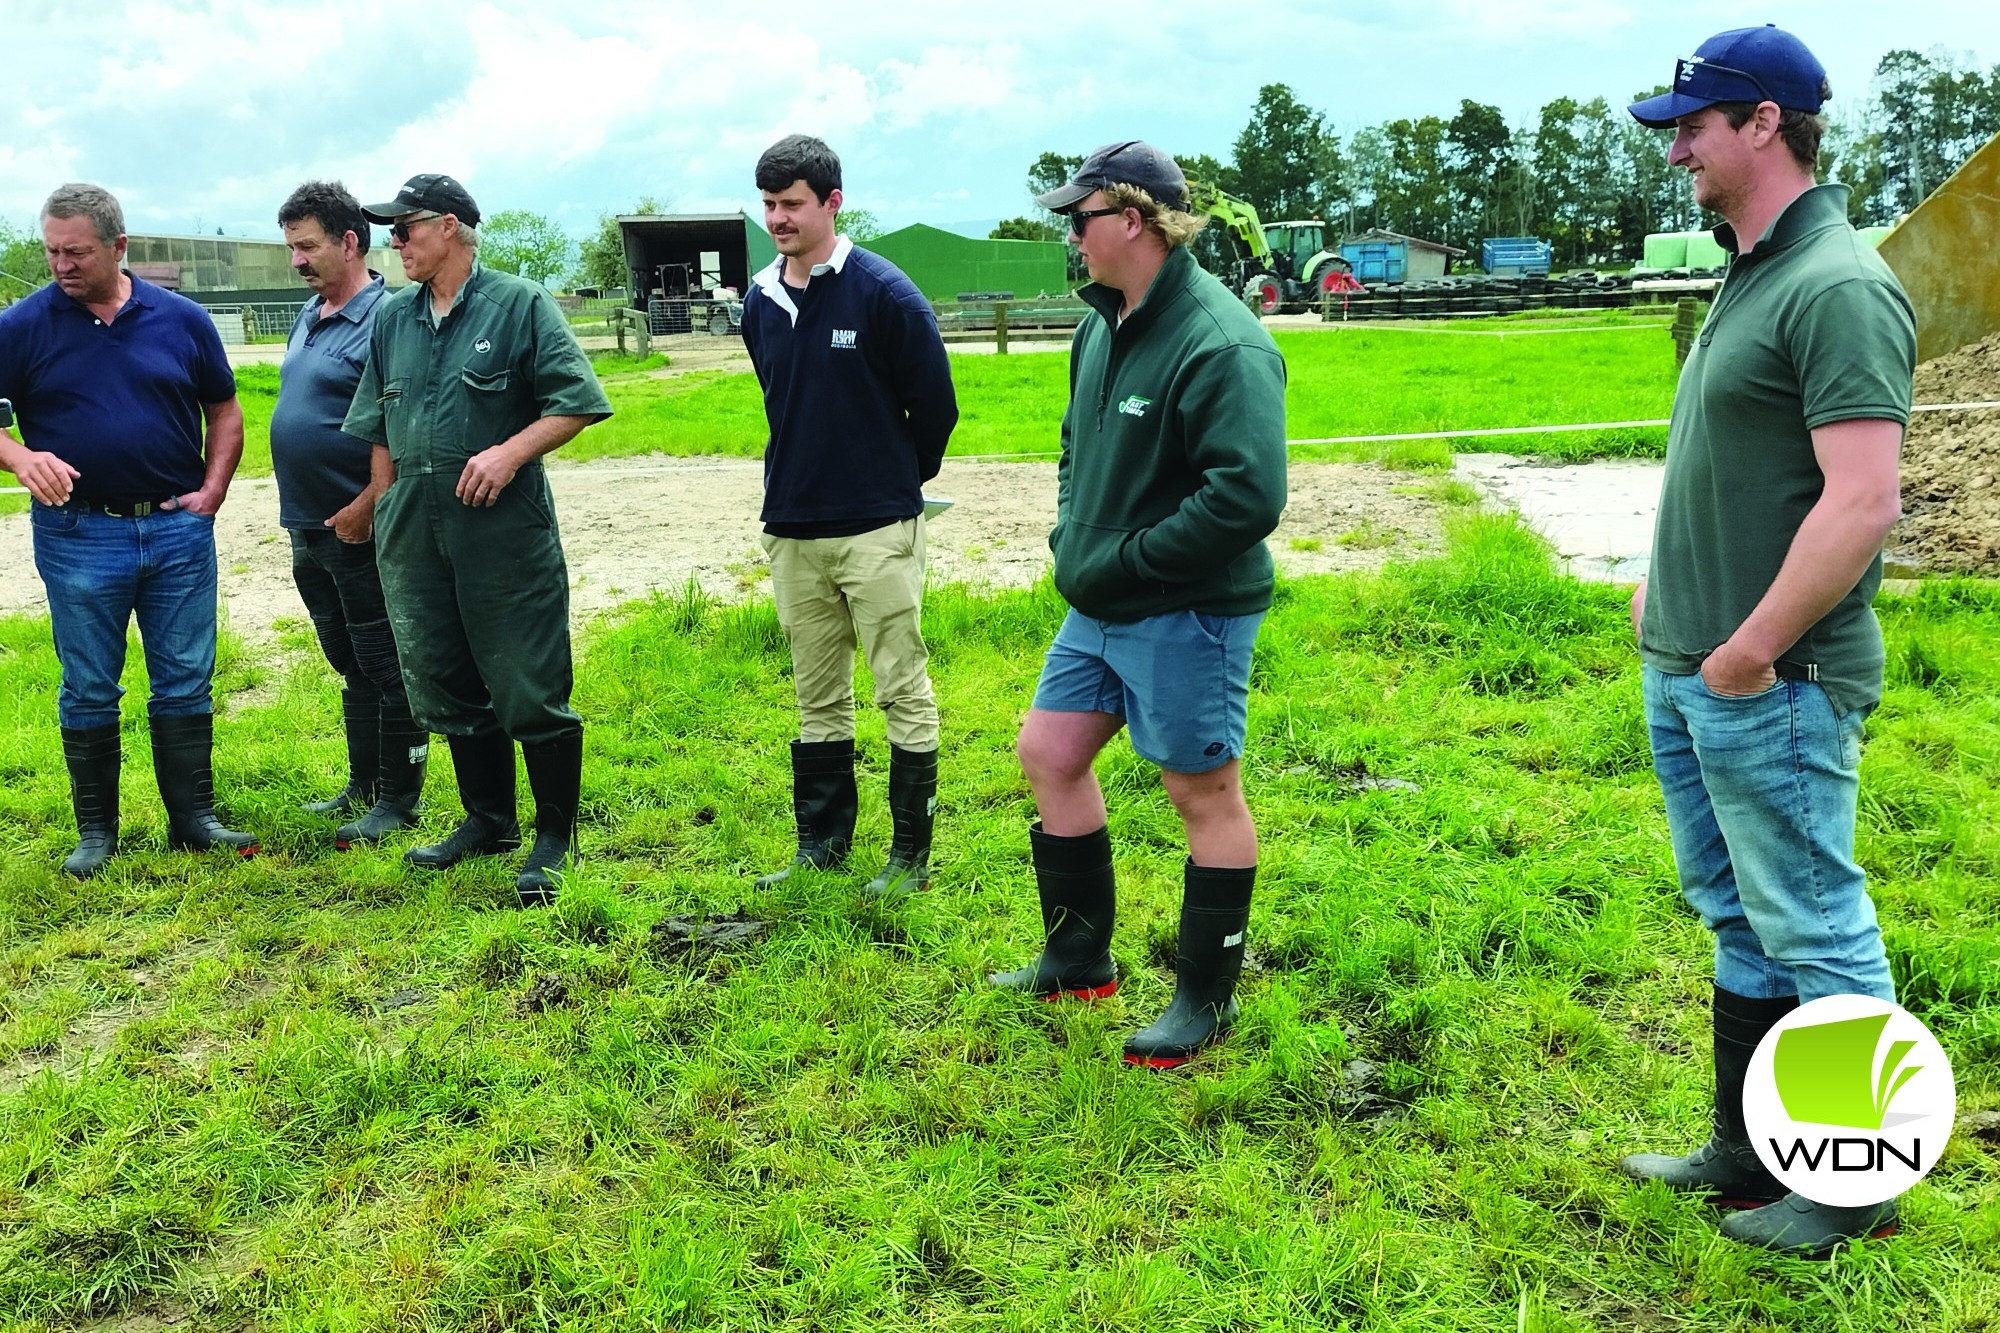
left=30, top=502, right=216, bottom=727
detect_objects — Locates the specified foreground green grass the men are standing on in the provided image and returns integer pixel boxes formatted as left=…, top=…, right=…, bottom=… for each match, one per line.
left=0, top=512, right=2000, bottom=1333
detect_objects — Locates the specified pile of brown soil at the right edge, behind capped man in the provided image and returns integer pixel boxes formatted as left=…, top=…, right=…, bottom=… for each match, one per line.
left=1888, top=334, right=2000, bottom=574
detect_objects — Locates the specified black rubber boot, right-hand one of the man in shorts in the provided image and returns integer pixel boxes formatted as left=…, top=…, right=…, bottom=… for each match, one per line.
left=1124, top=861, right=1256, bottom=1069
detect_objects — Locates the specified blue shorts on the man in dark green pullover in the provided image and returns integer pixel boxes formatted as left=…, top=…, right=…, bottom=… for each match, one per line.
left=1034, top=608, right=1264, bottom=773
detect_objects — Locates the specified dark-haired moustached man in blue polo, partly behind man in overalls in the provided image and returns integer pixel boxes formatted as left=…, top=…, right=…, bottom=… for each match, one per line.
left=270, top=180, right=430, bottom=847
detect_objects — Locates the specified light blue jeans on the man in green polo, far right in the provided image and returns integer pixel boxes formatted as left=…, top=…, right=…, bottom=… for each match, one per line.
left=1644, top=667, right=1896, bottom=1003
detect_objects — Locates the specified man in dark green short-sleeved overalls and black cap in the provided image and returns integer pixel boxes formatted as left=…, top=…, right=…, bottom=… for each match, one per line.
left=342, top=174, right=610, bottom=907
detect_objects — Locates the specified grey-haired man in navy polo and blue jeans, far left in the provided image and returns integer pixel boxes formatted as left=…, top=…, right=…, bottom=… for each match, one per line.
left=0, top=184, right=256, bottom=879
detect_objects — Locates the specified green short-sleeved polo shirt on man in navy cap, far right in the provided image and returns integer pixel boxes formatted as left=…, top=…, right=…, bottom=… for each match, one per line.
left=1640, top=184, right=1916, bottom=713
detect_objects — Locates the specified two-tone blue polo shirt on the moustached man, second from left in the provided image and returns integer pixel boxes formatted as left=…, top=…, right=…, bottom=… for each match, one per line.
left=270, top=274, right=386, bottom=528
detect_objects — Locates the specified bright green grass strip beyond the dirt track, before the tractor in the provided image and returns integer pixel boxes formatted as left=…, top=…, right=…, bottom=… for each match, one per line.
left=223, top=316, right=1674, bottom=476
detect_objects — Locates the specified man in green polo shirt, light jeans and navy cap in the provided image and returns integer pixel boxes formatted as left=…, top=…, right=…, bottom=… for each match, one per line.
left=1620, top=28, right=1916, bottom=1255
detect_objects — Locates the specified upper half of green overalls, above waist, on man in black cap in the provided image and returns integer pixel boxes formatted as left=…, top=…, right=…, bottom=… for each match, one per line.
left=342, top=264, right=612, bottom=476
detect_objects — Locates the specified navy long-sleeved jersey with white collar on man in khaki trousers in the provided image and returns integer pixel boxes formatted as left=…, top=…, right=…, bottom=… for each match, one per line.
left=744, top=236, right=958, bottom=536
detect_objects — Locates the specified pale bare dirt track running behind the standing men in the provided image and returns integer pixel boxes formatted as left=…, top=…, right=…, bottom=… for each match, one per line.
left=0, top=456, right=1440, bottom=642
